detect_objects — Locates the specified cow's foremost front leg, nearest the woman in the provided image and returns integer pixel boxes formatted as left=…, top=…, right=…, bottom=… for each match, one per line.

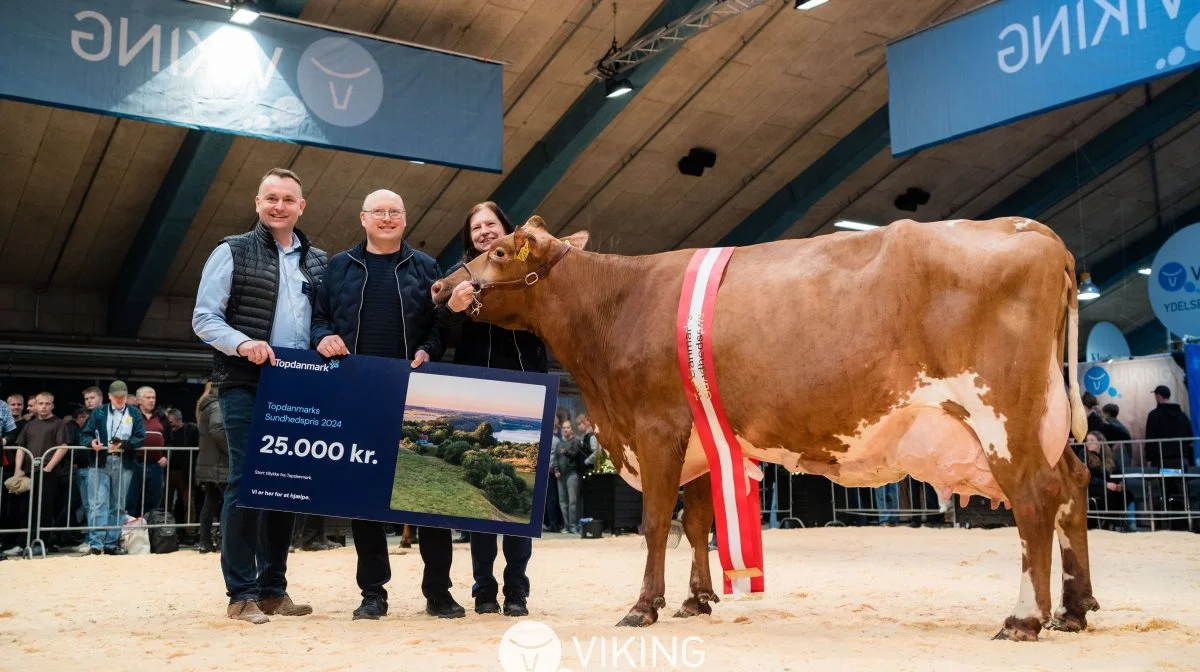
left=617, top=434, right=684, bottom=628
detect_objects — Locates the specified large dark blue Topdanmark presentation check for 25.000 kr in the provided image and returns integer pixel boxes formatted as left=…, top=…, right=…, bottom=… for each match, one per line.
left=240, top=348, right=558, bottom=536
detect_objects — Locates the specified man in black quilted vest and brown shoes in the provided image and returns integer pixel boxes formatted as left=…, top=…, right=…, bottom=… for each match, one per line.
left=192, top=168, right=328, bottom=624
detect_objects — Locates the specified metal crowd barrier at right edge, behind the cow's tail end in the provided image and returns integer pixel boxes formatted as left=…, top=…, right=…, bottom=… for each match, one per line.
left=1070, top=437, right=1200, bottom=532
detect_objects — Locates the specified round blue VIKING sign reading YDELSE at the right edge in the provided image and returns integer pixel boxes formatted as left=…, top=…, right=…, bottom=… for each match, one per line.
left=1148, top=224, right=1200, bottom=336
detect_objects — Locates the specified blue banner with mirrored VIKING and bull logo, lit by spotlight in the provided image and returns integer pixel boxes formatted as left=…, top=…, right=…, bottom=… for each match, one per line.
left=0, top=0, right=503, bottom=173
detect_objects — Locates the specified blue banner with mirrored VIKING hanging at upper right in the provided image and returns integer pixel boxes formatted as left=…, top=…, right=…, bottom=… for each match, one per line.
left=888, top=0, right=1200, bottom=156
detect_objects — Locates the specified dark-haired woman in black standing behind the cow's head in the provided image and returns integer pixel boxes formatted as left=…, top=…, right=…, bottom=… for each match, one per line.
left=443, top=202, right=546, bottom=616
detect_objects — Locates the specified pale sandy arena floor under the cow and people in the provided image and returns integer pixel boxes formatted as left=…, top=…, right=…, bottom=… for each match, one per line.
left=0, top=528, right=1200, bottom=672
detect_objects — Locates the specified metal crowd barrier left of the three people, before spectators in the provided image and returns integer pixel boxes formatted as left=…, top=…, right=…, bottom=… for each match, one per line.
left=0, top=446, right=210, bottom=558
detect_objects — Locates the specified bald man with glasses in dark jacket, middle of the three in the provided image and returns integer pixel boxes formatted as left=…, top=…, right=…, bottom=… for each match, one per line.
left=312, top=190, right=466, bottom=620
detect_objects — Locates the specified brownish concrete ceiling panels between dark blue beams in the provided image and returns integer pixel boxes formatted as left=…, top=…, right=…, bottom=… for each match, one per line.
left=0, top=0, right=1200, bottom=340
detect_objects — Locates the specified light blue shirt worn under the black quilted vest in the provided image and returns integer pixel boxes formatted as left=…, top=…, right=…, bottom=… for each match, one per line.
left=192, top=234, right=316, bottom=356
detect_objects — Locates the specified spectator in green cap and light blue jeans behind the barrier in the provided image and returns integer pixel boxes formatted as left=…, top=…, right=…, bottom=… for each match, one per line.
left=76, top=380, right=145, bottom=556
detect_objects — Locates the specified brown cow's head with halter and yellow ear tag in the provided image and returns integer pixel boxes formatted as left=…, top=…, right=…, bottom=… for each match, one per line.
left=432, top=215, right=588, bottom=331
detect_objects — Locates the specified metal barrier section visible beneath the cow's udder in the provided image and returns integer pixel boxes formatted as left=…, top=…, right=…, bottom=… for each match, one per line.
left=826, top=476, right=958, bottom=527
